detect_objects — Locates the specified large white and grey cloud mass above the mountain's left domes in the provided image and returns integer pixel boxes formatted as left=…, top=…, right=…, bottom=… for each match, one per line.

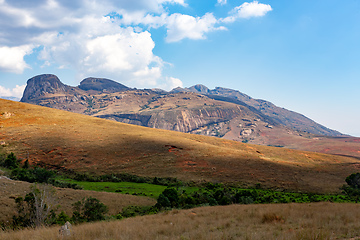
left=0, top=0, right=181, bottom=87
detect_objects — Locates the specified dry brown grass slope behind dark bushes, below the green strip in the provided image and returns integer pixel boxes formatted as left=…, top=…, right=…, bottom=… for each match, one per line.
left=0, top=179, right=156, bottom=223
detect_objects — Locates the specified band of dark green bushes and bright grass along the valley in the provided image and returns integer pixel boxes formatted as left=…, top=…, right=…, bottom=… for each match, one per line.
left=0, top=153, right=360, bottom=231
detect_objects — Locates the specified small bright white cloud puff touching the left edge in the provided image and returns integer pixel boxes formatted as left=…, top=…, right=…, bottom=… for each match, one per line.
left=0, top=45, right=32, bottom=74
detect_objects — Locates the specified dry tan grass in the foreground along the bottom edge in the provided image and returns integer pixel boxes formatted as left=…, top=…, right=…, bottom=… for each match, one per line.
left=0, top=203, right=360, bottom=240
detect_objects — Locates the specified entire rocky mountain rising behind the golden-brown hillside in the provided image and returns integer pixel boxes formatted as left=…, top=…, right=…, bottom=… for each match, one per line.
left=21, top=74, right=360, bottom=158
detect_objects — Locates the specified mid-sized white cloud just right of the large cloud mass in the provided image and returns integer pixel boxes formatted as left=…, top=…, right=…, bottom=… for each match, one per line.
left=166, top=13, right=225, bottom=42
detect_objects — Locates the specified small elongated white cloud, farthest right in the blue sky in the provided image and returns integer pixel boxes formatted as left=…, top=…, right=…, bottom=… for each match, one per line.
left=221, top=1, right=272, bottom=23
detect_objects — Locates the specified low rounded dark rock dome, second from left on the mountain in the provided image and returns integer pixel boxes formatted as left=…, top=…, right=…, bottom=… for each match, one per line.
left=79, top=77, right=129, bottom=92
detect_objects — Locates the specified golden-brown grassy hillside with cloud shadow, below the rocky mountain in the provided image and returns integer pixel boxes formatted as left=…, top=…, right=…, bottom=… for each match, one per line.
left=0, top=99, right=359, bottom=192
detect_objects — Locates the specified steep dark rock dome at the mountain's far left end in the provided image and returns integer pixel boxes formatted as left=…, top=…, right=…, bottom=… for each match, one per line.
left=21, top=74, right=66, bottom=102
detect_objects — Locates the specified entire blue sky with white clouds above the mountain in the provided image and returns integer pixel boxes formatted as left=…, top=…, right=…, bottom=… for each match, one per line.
left=0, top=0, right=360, bottom=137
